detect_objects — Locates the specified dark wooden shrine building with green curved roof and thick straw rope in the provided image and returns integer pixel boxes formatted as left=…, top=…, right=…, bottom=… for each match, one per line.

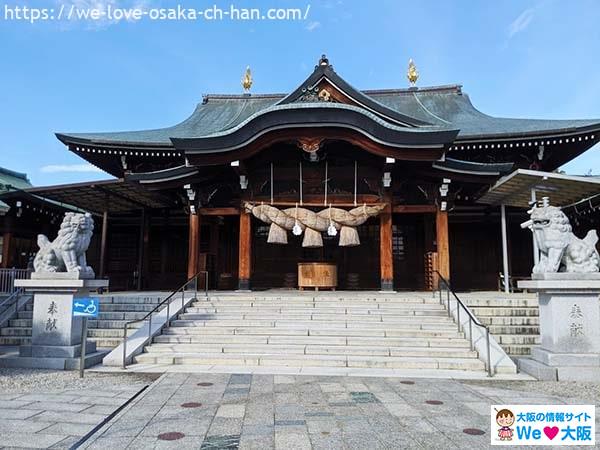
left=2, top=56, right=600, bottom=291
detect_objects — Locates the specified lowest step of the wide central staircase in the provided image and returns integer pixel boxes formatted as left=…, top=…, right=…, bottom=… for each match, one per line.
left=134, top=353, right=484, bottom=370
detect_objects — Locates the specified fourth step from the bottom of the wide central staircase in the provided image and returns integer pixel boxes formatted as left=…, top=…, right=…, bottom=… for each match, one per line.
left=163, top=326, right=464, bottom=338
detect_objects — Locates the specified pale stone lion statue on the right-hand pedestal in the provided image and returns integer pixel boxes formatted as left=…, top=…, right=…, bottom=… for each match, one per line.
left=521, top=204, right=600, bottom=273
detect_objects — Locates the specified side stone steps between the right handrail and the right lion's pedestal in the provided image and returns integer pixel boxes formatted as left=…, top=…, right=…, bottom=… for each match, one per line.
left=460, top=292, right=540, bottom=358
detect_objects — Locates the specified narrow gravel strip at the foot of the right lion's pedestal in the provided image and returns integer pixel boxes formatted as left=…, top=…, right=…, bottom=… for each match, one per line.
left=464, top=381, right=600, bottom=404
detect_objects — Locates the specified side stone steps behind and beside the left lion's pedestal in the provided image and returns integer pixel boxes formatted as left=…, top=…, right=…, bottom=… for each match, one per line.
left=0, top=292, right=168, bottom=348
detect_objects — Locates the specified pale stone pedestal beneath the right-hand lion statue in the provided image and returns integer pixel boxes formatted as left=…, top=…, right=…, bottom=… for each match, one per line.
left=518, top=273, right=600, bottom=381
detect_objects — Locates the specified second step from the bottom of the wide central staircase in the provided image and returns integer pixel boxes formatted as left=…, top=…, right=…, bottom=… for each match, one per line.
left=146, top=344, right=477, bottom=358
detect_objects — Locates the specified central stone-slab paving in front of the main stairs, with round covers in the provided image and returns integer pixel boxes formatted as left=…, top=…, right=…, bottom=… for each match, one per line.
left=84, top=373, right=598, bottom=450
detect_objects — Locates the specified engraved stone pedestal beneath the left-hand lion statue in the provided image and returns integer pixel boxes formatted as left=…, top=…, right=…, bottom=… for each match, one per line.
left=8, top=273, right=108, bottom=369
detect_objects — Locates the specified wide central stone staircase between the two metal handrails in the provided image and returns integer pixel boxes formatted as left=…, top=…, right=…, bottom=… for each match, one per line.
left=134, top=292, right=484, bottom=371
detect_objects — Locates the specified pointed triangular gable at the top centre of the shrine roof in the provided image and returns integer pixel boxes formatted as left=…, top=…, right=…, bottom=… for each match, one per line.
left=276, top=55, right=432, bottom=128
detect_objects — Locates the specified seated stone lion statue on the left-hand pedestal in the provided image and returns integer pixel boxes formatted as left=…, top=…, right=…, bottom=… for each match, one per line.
left=33, top=213, right=94, bottom=278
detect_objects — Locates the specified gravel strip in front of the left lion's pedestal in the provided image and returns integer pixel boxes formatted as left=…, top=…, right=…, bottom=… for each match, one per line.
left=0, top=368, right=158, bottom=394
